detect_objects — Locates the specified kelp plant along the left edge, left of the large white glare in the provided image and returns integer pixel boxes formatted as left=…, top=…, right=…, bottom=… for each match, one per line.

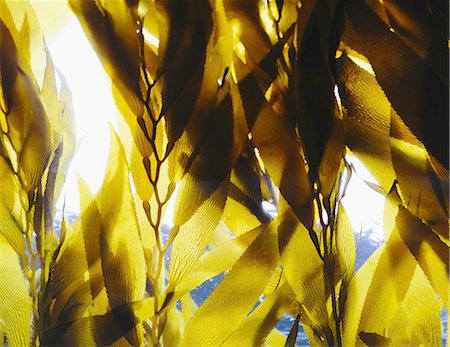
left=0, top=1, right=75, bottom=346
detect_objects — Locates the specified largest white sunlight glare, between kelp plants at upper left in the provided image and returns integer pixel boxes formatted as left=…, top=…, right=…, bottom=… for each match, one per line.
left=49, top=18, right=117, bottom=212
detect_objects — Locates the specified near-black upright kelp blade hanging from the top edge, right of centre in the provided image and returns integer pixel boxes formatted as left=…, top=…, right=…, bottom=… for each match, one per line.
left=290, top=1, right=340, bottom=181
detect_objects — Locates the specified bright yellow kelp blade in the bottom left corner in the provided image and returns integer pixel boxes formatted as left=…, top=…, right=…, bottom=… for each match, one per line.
left=0, top=235, right=31, bottom=347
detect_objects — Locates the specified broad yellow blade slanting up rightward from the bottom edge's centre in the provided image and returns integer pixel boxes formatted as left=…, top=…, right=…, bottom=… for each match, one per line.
left=181, top=224, right=278, bottom=346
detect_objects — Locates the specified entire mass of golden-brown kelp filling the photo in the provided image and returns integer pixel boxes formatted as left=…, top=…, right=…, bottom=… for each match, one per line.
left=0, top=0, right=450, bottom=346
